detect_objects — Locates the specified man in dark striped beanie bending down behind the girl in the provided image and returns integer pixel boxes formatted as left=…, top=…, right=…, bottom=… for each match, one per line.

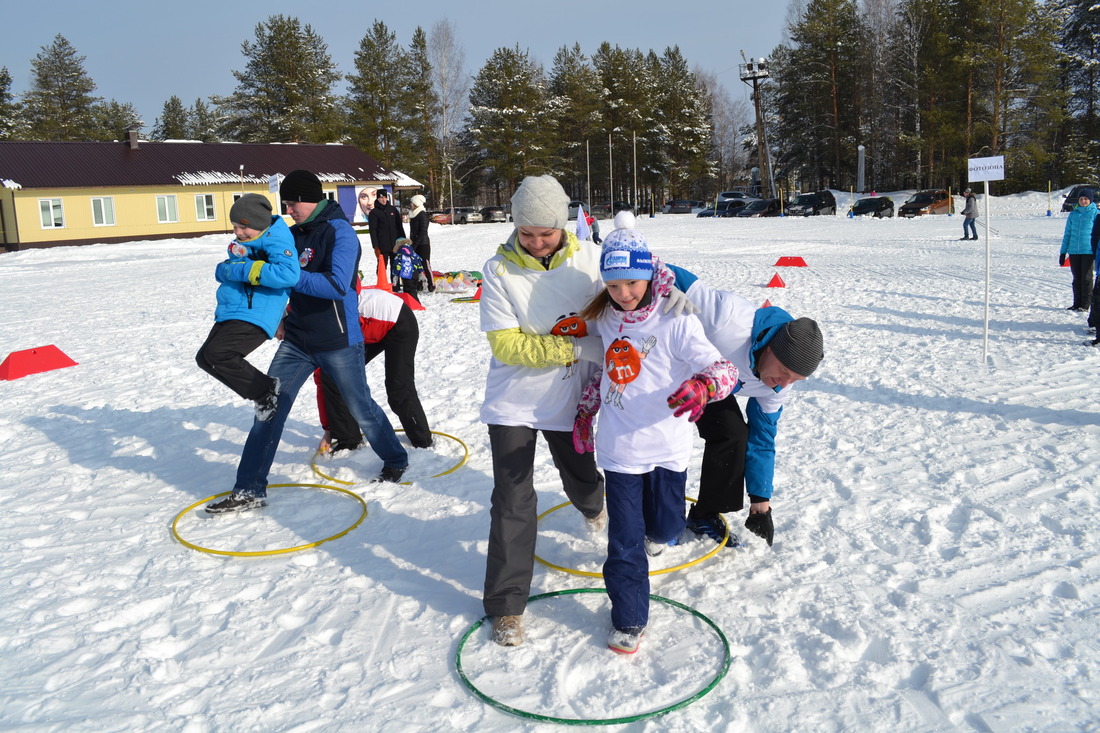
left=668, top=265, right=825, bottom=547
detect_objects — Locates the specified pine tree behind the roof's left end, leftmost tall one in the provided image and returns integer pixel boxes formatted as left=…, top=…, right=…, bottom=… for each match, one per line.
left=23, top=33, right=100, bottom=141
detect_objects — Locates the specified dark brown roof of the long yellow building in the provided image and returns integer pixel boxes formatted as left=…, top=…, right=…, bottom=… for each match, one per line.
left=0, top=141, right=403, bottom=188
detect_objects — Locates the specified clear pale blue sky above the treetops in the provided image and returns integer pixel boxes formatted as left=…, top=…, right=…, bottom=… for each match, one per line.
left=0, top=0, right=787, bottom=127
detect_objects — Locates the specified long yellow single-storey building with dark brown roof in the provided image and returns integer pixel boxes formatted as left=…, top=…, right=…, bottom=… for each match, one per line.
left=0, top=133, right=419, bottom=251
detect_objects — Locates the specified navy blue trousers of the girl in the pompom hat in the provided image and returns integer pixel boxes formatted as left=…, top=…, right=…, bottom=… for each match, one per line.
left=604, top=467, right=688, bottom=631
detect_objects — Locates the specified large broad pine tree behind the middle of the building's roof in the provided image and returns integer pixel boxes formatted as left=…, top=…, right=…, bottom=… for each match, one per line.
left=215, top=15, right=342, bottom=142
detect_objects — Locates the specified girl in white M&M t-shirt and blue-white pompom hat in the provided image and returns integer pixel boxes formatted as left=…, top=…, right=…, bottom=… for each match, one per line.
left=573, top=212, right=737, bottom=654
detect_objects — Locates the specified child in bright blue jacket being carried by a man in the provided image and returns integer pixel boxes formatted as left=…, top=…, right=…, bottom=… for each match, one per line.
left=195, top=194, right=300, bottom=419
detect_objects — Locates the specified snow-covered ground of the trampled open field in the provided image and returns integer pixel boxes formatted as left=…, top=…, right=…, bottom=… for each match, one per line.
left=0, top=194, right=1100, bottom=732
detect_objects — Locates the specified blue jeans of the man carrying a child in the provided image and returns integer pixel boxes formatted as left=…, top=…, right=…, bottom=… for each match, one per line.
left=233, top=341, right=409, bottom=496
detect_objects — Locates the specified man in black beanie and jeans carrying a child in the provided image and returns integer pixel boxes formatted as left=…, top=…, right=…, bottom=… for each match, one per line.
left=206, top=171, right=408, bottom=514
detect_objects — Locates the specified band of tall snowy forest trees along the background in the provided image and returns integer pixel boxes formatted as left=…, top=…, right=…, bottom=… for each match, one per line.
left=0, top=0, right=1100, bottom=205
